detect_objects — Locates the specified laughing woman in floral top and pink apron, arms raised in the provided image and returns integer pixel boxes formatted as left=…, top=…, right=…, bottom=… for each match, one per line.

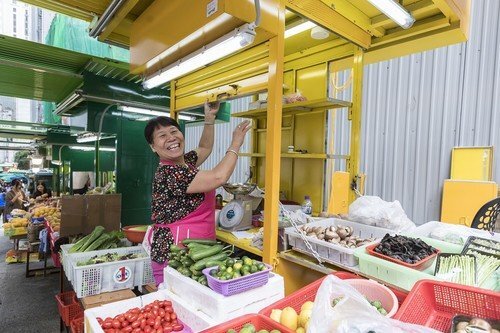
left=144, top=103, right=251, bottom=285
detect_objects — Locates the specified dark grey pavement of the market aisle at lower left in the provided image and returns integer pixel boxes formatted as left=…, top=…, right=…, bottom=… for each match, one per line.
left=0, top=227, right=59, bottom=333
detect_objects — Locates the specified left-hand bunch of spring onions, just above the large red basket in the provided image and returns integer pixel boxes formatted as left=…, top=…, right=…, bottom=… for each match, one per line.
left=436, top=254, right=476, bottom=286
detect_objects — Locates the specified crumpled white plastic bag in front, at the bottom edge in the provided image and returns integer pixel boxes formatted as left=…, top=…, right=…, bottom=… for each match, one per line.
left=307, top=275, right=438, bottom=333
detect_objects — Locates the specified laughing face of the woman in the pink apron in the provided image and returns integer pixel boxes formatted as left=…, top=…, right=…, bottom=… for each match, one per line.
left=151, top=126, right=184, bottom=161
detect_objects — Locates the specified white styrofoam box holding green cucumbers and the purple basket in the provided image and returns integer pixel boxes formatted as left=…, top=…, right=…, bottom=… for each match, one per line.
left=164, top=267, right=285, bottom=324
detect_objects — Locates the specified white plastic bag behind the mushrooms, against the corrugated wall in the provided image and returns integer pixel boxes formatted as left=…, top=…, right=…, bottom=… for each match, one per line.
left=349, top=195, right=415, bottom=232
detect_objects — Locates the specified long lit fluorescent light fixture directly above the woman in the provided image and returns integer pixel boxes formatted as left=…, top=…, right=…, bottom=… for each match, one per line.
left=143, top=24, right=255, bottom=89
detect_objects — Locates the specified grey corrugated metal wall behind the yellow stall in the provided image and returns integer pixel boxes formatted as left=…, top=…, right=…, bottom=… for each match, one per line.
left=335, top=0, right=500, bottom=224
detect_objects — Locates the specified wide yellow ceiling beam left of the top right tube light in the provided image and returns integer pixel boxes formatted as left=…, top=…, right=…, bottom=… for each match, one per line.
left=286, top=0, right=372, bottom=49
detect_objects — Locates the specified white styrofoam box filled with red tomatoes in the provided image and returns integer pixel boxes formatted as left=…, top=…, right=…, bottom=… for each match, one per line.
left=84, top=290, right=216, bottom=333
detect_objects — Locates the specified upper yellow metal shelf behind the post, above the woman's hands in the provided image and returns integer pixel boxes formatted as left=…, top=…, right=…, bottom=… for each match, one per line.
left=231, top=98, right=352, bottom=118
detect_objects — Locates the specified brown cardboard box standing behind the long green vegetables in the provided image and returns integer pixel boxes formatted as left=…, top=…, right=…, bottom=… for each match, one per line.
left=59, top=194, right=122, bottom=236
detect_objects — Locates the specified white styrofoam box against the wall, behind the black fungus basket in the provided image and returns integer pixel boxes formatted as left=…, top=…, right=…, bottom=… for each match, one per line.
left=408, top=221, right=500, bottom=244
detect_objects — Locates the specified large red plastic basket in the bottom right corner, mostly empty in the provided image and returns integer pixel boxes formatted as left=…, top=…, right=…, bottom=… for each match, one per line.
left=394, top=280, right=500, bottom=332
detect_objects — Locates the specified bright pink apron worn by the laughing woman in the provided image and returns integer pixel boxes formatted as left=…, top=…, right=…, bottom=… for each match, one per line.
left=148, top=161, right=216, bottom=285
